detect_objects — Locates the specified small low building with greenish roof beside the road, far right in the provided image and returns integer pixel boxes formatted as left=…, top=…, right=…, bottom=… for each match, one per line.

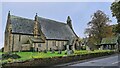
left=100, top=37, right=118, bottom=50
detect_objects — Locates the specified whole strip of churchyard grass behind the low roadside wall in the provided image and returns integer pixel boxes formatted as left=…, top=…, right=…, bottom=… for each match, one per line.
left=0, top=50, right=115, bottom=63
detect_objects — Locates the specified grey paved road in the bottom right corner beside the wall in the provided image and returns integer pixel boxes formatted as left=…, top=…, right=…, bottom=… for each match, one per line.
left=57, top=54, right=120, bottom=68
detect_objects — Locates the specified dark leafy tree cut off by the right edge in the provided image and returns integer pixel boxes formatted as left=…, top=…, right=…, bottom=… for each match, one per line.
left=110, top=1, right=120, bottom=34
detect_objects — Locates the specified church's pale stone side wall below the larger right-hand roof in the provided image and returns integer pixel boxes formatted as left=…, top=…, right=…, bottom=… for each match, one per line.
left=33, top=40, right=67, bottom=51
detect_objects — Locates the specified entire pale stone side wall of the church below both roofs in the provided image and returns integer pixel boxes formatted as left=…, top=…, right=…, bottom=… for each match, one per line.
left=5, top=34, right=68, bottom=52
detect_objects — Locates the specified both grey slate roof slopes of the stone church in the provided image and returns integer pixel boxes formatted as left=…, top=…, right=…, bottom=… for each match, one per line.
left=11, top=15, right=76, bottom=40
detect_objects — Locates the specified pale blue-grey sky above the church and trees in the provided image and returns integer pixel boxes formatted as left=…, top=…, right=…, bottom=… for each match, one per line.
left=0, top=2, right=116, bottom=48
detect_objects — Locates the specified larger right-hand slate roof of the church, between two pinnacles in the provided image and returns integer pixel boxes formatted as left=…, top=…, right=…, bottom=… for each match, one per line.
left=38, top=17, right=76, bottom=40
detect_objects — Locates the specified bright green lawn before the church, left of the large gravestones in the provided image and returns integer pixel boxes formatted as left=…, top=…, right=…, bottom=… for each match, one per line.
left=2, top=51, right=67, bottom=63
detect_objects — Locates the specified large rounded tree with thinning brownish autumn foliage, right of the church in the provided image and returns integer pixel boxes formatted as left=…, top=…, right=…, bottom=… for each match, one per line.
left=85, top=10, right=112, bottom=48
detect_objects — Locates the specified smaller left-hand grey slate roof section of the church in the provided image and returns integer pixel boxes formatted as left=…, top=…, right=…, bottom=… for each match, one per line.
left=10, top=15, right=34, bottom=34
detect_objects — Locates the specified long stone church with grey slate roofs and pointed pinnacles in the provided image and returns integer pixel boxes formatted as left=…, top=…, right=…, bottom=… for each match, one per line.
left=4, top=11, right=80, bottom=52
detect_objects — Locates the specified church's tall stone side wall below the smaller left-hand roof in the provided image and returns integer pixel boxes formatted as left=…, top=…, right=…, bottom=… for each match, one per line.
left=5, top=34, right=33, bottom=52
